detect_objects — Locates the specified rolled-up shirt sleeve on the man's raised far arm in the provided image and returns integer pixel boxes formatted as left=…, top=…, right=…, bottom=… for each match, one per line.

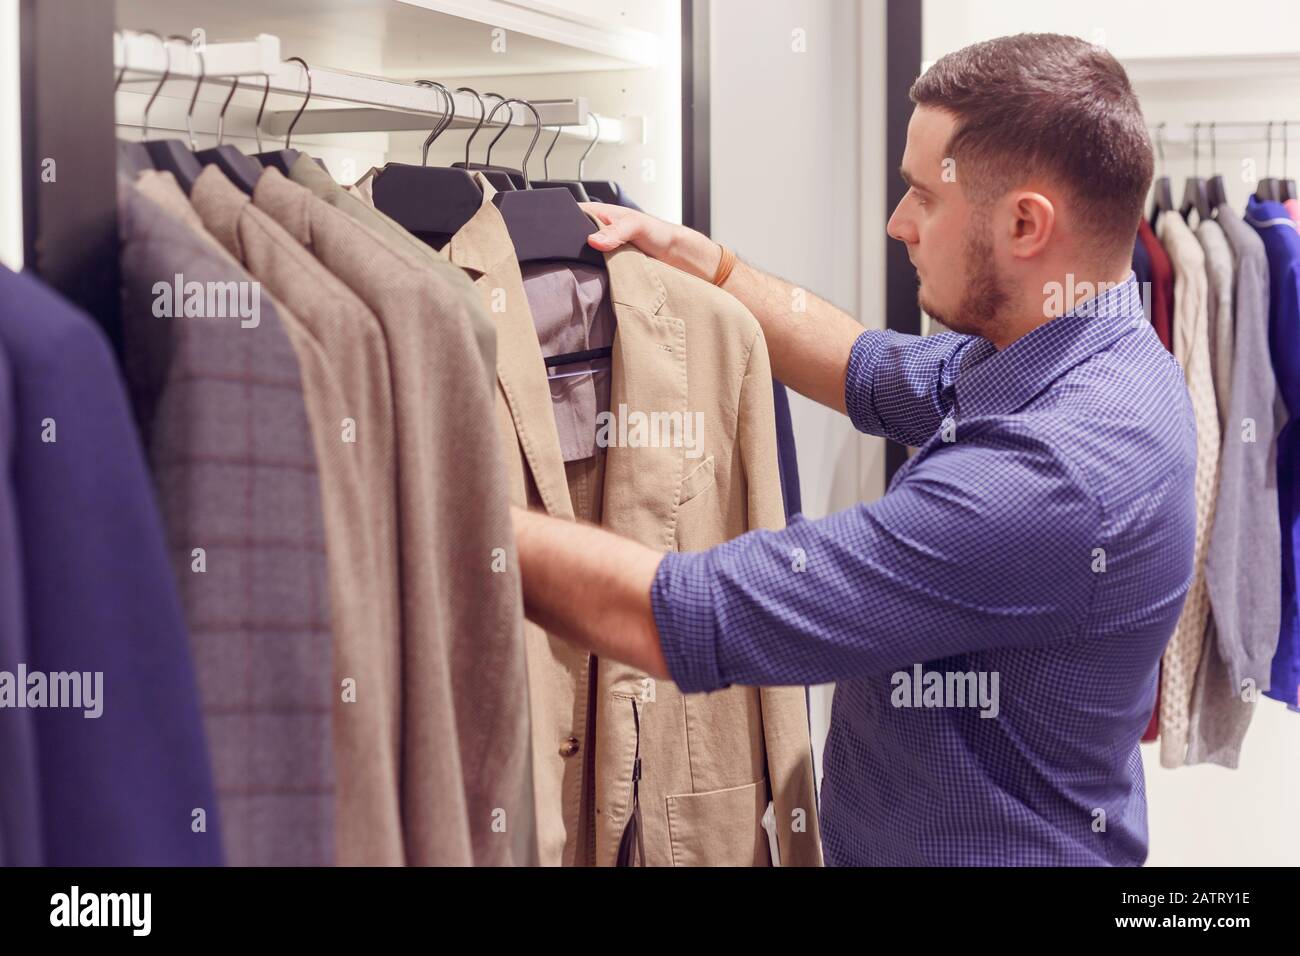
left=844, top=329, right=975, bottom=446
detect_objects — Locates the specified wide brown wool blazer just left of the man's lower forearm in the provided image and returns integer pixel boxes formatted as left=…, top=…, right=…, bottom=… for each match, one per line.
left=254, top=169, right=536, bottom=865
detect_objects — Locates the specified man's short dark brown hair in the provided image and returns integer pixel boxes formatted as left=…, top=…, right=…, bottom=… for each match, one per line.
left=910, top=34, right=1152, bottom=252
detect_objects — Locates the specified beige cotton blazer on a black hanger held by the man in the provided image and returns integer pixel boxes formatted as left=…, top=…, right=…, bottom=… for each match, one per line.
left=442, top=176, right=822, bottom=866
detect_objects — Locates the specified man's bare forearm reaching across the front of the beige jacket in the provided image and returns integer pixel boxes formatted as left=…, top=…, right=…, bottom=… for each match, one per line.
left=511, top=507, right=670, bottom=678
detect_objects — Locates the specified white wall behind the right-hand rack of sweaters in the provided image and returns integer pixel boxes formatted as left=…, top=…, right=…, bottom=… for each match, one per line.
left=922, top=0, right=1300, bottom=866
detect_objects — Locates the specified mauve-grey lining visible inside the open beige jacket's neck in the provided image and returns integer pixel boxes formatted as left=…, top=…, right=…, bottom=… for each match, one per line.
left=520, top=263, right=615, bottom=462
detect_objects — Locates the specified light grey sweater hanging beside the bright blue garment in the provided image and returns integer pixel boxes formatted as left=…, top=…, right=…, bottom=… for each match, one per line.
left=1187, top=206, right=1286, bottom=767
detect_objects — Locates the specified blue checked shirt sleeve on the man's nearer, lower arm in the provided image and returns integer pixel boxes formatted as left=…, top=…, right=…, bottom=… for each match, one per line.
left=651, top=424, right=1105, bottom=693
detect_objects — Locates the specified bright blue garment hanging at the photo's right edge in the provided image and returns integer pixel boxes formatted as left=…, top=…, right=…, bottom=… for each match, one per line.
left=1245, top=196, right=1300, bottom=709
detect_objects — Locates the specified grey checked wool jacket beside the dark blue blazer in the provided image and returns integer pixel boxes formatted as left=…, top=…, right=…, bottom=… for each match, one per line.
left=118, top=173, right=334, bottom=866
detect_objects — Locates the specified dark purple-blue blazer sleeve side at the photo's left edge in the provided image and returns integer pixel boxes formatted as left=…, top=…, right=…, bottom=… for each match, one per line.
left=0, top=268, right=221, bottom=866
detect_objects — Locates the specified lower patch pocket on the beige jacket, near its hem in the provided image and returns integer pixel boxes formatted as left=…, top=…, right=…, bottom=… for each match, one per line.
left=668, top=780, right=772, bottom=866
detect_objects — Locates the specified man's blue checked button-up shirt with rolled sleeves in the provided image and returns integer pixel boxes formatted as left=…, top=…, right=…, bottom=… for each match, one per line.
left=651, top=276, right=1196, bottom=865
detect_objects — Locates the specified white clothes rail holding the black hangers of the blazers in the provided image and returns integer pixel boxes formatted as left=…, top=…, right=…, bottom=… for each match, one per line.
left=113, top=31, right=627, bottom=144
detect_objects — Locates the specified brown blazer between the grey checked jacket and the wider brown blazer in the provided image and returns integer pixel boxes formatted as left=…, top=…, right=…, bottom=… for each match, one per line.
left=190, top=166, right=406, bottom=866
